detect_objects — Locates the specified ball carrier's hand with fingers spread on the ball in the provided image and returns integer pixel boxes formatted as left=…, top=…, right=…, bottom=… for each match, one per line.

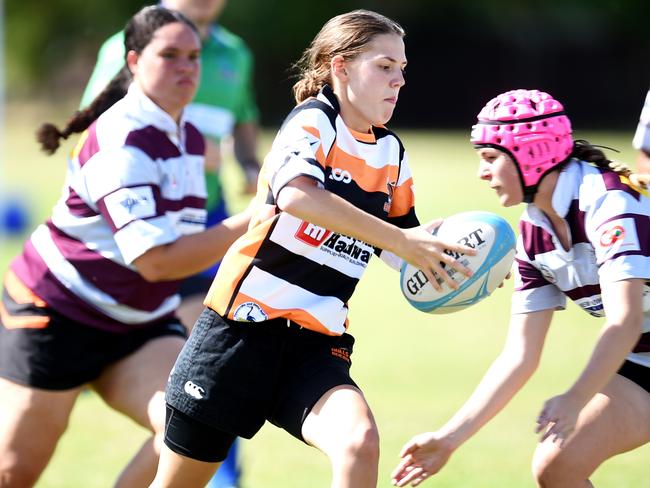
left=395, top=219, right=476, bottom=291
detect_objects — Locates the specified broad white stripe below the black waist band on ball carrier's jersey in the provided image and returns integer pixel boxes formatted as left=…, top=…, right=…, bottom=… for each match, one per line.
left=239, top=266, right=348, bottom=335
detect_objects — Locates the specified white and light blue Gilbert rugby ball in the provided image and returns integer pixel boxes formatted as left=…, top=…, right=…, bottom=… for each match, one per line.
left=400, top=212, right=515, bottom=314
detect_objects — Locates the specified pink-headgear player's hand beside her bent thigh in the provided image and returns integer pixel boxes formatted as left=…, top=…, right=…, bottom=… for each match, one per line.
left=535, top=393, right=585, bottom=447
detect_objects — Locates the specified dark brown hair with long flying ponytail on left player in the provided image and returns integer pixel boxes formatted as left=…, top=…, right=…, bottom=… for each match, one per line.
left=36, top=5, right=199, bottom=154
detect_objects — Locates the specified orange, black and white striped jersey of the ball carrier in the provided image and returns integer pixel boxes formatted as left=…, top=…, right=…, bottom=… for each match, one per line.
left=205, top=86, right=418, bottom=335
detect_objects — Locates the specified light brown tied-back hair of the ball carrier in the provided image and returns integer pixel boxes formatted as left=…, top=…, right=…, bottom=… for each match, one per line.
left=293, top=10, right=404, bottom=103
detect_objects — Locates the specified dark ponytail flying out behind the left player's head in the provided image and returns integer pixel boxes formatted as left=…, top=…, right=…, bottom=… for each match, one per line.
left=36, top=64, right=132, bottom=155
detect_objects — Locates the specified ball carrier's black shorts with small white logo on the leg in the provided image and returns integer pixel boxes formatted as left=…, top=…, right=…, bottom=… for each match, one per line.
left=166, top=308, right=357, bottom=457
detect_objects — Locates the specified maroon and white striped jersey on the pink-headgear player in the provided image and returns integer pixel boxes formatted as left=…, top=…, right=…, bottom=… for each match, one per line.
left=512, top=159, right=650, bottom=367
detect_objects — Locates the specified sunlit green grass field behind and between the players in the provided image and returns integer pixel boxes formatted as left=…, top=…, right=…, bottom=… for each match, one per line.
left=0, top=102, right=650, bottom=488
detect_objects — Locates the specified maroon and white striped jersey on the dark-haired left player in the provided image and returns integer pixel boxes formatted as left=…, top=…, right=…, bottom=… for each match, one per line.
left=5, top=84, right=206, bottom=331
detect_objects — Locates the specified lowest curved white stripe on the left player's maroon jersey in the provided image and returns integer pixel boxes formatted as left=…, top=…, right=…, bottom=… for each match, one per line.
left=32, top=225, right=181, bottom=324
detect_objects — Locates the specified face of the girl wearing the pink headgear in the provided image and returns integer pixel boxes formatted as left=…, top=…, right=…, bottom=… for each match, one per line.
left=476, top=147, right=524, bottom=207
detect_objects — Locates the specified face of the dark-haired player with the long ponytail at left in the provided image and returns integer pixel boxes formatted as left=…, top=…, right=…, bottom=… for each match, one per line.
left=127, top=22, right=201, bottom=121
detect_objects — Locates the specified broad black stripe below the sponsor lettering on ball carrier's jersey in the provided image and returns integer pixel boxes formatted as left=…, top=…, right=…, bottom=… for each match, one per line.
left=253, top=240, right=359, bottom=302
